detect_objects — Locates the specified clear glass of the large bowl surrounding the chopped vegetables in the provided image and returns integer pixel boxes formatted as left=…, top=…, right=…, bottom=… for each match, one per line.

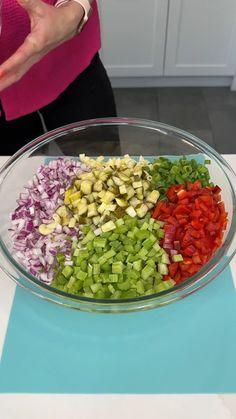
left=0, top=118, right=236, bottom=312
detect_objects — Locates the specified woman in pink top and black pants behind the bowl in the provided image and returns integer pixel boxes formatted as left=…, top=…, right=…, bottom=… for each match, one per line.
left=0, top=0, right=116, bottom=154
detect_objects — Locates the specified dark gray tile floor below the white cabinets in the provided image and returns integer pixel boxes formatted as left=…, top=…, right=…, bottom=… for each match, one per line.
left=114, top=87, right=236, bottom=154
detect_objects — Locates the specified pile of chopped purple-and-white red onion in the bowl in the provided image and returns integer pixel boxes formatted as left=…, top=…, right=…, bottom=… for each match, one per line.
left=11, top=158, right=90, bottom=284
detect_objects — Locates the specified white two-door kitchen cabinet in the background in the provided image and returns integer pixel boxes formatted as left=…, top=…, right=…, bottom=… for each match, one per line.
left=98, top=0, right=236, bottom=78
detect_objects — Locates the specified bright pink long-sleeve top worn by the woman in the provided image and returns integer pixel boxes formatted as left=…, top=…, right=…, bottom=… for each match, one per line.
left=0, top=0, right=101, bottom=120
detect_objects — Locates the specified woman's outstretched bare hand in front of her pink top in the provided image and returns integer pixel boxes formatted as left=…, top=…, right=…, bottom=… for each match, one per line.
left=0, top=0, right=84, bottom=91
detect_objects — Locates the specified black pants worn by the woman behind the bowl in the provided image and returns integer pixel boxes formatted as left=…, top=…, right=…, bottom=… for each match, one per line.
left=0, top=54, right=116, bottom=155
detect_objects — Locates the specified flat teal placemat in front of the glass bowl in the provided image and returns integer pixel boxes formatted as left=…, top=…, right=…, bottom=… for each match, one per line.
left=0, top=268, right=236, bottom=394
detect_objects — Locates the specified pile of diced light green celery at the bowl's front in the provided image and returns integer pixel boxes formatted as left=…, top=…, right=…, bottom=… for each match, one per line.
left=52, top=213, right=174, bottom=299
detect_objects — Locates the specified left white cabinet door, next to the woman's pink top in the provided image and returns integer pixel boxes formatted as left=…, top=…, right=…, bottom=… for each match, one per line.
left=99, top=0, right=168, bottom=77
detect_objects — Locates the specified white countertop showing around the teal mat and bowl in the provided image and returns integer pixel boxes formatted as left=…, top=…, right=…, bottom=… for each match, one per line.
left=0, top=155, right=236, bottom=419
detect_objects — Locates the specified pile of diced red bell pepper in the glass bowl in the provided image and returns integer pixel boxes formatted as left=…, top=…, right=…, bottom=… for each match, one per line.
left=152, top=181, right=228, bottom=283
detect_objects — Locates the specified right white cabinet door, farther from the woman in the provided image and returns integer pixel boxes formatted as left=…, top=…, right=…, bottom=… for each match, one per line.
left=164, top=0, right=236, bottom=76
